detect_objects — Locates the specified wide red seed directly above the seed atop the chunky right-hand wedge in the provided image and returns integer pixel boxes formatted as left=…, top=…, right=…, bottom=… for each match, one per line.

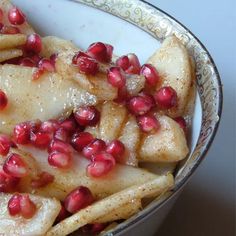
left=128, top=94, right=154, bottom=115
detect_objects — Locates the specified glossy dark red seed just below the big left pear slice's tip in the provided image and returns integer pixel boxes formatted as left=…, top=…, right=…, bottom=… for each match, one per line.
left=74, top=106, right=100, bottom=126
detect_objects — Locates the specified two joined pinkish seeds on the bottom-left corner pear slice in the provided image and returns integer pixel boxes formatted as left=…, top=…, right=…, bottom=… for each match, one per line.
left=8, top=193, right=37, bottom=219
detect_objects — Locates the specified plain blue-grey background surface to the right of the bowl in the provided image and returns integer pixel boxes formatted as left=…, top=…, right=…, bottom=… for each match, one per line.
left=148, top=0, right=236, bottom=236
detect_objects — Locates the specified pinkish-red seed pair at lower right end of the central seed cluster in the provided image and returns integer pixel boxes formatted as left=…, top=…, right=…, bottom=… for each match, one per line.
left=87, top=151, right=116, bottom=177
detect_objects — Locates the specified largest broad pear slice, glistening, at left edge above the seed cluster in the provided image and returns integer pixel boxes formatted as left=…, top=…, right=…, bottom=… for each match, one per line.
left=0, top=65, right=97, bottom=133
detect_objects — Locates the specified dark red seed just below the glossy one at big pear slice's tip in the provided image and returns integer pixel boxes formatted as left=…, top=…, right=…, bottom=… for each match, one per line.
left=71, top=132, right=93, bottom=152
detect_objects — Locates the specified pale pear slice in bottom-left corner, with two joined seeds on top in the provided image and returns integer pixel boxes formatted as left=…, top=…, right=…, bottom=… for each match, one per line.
left=0, top=193, right=61, bottom=236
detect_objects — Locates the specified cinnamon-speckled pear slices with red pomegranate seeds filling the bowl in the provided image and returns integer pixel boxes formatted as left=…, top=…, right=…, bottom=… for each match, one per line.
left=0, top=0, right=199, bottom=236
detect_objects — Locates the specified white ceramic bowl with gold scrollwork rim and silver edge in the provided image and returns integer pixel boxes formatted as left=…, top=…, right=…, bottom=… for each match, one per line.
left=14, top=0, right=222, bottom=236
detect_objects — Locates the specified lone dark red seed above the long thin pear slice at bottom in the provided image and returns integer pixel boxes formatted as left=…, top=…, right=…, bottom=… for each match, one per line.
left=64, top=186, right=94, bottom=213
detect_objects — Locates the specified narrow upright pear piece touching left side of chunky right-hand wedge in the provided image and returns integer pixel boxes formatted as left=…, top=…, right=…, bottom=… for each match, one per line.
left=119, top=115, right=141, bottom=166
